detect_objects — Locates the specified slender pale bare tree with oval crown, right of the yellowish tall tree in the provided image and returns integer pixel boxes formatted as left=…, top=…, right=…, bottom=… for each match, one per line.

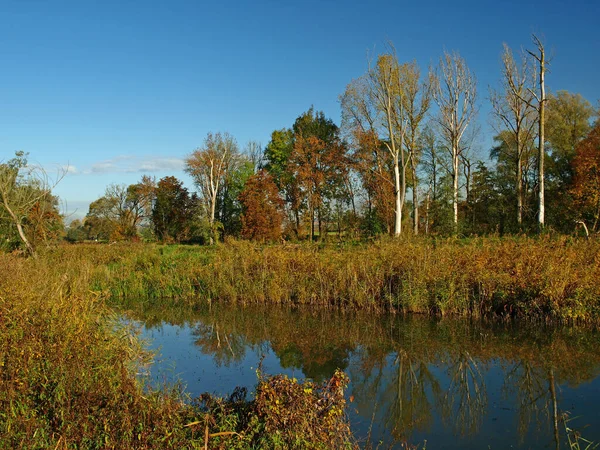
left=433, top=52, right=477, bottom=233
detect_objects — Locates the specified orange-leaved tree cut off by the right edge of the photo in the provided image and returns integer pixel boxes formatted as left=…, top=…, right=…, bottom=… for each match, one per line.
left=571, top=120, right=600, bottom=231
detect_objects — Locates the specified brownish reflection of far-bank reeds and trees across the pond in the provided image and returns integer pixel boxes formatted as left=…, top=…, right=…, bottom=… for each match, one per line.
left=127, top=305, right=600, bottom=441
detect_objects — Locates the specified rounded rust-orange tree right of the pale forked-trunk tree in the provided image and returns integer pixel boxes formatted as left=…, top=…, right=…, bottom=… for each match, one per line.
left=240, top=170, right=284, bottom=241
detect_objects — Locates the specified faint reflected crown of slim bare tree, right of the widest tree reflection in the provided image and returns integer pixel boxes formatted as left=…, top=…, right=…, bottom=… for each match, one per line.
left=442, top=351, right=487, bottom=434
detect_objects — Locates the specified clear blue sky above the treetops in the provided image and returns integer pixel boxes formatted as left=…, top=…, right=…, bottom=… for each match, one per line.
left=0, top=0, right=600, bottom=216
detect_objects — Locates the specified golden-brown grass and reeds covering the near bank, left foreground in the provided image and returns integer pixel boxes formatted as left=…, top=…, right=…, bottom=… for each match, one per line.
left=0, top=247, right=352, bottom=449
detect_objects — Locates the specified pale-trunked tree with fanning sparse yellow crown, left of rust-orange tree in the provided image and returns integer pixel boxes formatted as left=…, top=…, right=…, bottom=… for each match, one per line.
left=185, top=133, right=239, bottom=242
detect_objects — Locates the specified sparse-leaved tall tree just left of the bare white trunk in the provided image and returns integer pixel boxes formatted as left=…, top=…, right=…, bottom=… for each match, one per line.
left=490, top=44, right=537, bottom=227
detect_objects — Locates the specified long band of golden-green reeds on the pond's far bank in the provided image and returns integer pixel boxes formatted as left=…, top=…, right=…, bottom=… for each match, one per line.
left=82, top=237, right=600, bottom=323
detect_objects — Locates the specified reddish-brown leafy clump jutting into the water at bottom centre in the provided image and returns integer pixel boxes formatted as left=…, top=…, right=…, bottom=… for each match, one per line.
left=190, top=371, right=357, bottom=449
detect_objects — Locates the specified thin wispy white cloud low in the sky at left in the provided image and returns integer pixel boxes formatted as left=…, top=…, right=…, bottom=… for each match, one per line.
left=82, top=156, right=184, bottom=174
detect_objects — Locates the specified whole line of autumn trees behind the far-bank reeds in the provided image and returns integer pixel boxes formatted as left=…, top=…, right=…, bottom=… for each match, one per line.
left=0, top=36, right=600, bottom=251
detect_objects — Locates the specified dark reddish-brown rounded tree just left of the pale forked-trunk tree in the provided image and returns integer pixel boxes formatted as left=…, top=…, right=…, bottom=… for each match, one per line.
left=152, top=176, right=198, bottom=242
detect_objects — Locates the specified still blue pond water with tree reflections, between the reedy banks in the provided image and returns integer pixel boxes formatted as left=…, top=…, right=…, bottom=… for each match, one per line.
left=128, top=306, right=600, bottom=449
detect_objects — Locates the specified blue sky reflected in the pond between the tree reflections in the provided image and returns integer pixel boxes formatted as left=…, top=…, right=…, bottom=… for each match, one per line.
left=136, top=324, right=600, bottom=449
